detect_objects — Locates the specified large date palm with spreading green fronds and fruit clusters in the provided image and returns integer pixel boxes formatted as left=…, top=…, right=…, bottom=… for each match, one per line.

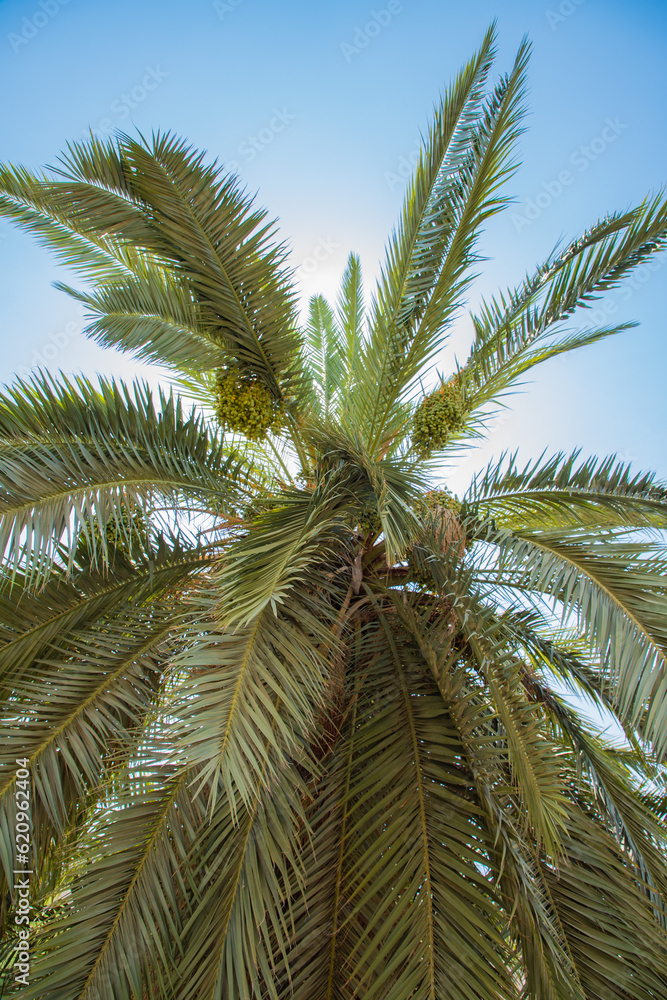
left=0, top=30, right=667, bottom=1000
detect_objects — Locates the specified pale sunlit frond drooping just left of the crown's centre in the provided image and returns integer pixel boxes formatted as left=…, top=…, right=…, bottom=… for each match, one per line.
left=169, top=587, right=335, bottom=809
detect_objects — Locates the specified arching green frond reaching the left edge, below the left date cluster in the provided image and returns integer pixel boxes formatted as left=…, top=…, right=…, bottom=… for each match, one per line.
left=0, top=375, right=248, bottom=582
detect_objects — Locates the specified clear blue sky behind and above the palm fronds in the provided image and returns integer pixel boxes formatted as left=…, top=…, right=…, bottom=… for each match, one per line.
left=0, top=0, right=667, bottom=488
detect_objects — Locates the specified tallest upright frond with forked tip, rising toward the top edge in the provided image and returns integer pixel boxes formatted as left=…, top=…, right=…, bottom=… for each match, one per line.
left=359, top=34, right=528, bottom=452
